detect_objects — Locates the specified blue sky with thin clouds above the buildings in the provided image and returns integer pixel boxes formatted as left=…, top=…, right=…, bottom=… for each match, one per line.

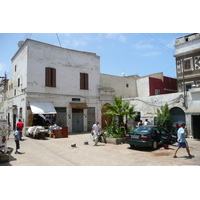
left=0, top=33, right=189, bottom=78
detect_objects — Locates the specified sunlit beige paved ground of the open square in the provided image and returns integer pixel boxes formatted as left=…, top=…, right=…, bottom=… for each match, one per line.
left=0, top=133, right=200, bottom=166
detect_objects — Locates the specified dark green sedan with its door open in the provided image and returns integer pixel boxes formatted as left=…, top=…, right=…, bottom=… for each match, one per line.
left=125, top=125, right=177, bottom=149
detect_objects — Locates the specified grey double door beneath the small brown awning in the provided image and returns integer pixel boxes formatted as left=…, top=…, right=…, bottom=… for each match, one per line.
left=72, top=108, right=84, bottom=132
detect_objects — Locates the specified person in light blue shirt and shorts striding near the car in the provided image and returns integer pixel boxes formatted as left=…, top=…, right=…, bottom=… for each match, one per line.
left=173, top=123, right=194, bottom=158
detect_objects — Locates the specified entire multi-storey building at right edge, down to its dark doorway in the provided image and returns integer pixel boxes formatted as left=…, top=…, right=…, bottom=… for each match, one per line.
left=174, top=33, right=200, bottom=138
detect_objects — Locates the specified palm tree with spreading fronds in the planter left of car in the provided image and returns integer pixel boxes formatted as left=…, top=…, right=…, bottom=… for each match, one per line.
left=104, top=97, right=136, bottom=137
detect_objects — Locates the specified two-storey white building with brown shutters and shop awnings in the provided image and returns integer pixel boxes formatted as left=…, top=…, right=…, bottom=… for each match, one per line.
left=1, top=39, right=101, bottom=132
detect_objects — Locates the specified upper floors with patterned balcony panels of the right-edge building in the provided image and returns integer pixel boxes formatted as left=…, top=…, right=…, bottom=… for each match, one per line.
left=174, top=33, right=200, bottom=92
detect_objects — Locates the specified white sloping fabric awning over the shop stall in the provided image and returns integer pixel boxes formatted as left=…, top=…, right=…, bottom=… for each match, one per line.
left=30, top=102, right=57, bottom=114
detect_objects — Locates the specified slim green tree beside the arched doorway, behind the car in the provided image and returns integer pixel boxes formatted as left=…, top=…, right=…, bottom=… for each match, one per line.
left=155, top=103, right=173, bottom=131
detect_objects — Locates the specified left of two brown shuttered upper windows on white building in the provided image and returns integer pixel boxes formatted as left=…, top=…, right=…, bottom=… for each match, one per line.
left=45, top=67, right=56, bottom=87
